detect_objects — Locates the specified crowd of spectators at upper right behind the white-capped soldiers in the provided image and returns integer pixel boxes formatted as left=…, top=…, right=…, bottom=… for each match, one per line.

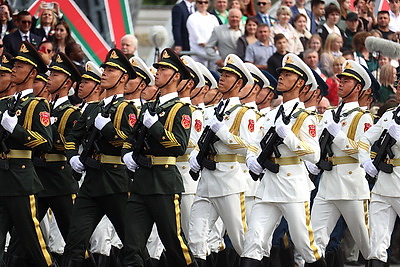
left=172, top=0, right=400, bottom=107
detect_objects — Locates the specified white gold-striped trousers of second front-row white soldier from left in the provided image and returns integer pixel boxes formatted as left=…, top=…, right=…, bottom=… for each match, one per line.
left=242, top=200, right=321, bottom=263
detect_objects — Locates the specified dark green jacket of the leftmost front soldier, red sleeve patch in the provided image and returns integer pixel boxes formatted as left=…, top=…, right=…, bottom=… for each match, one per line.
left=0, top=94, right=53, bottom=196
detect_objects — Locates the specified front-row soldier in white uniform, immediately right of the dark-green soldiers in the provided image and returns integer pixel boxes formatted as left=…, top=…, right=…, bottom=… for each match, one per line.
left=189, top=54, right=256, bottom=266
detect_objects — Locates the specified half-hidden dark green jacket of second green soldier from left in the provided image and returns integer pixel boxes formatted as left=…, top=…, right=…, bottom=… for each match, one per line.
left=35, top=100, right=81, bottom=197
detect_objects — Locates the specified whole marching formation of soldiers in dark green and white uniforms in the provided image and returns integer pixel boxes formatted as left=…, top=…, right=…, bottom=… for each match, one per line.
left=0, top=38, right=400, bottom=267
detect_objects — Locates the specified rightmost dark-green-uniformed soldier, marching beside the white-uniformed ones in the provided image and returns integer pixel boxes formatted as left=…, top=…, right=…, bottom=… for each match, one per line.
left=122, top=49, right=197, bottom=267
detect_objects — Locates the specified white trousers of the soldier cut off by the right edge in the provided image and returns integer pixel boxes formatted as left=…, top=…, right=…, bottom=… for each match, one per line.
left=368, top=193, right=400, bottom=262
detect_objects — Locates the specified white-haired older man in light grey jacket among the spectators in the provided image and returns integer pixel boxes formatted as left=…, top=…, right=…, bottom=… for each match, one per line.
left=206, top=9, right=242, bottom=67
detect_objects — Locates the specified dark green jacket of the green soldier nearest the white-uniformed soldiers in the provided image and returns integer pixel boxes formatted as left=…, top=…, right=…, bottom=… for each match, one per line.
left=122, top=98, right=192, bottom=195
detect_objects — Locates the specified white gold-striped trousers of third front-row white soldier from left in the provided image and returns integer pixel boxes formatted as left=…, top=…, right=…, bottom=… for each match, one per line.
left=311, top=197, right=370, bottom=258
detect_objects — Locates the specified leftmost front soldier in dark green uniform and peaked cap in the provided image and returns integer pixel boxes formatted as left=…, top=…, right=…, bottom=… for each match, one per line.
left=0, top=42, right=53, bottom=267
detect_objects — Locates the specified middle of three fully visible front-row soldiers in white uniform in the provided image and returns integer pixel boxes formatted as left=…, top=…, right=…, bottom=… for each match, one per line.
left=241, top=54, right=326, bottom=267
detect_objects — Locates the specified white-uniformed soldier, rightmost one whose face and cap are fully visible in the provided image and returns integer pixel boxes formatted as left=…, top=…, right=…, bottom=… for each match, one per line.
left=311, top=60, right=373, bottom=264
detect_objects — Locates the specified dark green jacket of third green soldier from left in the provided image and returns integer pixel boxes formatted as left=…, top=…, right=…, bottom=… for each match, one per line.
left=66, top=97, right=137, bottom=197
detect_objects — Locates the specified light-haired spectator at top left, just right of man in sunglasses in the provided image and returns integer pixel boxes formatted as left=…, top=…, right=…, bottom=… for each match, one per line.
left=31, top=2, right=61, bottom=41
